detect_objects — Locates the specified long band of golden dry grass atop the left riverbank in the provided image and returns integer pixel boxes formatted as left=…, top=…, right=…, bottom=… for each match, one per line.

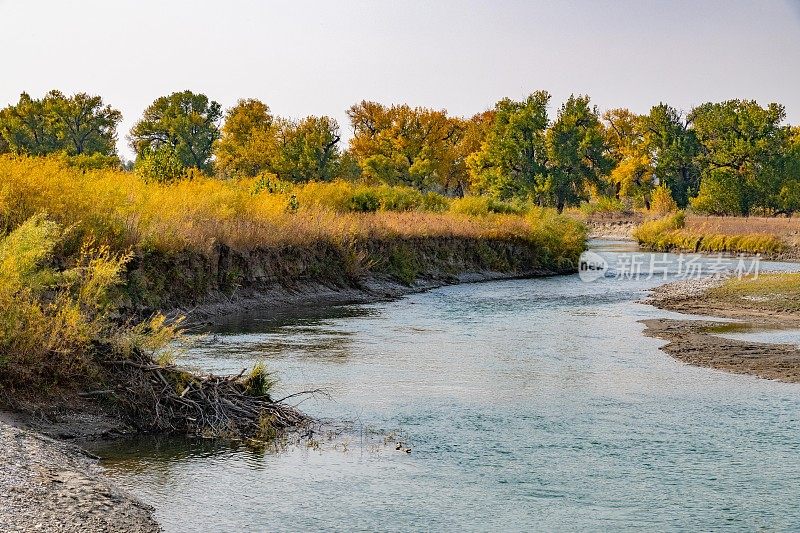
left=0, top=156, right=583, bottom=258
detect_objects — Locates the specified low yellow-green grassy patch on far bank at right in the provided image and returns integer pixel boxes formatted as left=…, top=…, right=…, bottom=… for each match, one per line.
left=633, top=212, right=793, bottom=257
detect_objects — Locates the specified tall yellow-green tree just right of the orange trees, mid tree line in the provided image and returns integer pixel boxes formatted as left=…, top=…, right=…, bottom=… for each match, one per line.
left=467, top=91, right=550, bottom=199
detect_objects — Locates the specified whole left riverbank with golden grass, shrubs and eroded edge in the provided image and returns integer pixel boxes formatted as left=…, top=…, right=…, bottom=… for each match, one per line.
left=0, top=156, right=586, bottom=430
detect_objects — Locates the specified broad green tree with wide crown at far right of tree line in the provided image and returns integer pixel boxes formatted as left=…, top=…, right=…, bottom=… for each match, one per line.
left=690, top=100, right=791, bottom=216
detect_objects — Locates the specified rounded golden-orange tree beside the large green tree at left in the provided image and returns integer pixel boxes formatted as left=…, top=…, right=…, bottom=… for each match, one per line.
left=214, top=99, right=278, bottom=181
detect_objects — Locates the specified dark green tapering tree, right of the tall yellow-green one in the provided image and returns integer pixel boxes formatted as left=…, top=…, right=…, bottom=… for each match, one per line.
left=545, top=95, right=613, bottom=212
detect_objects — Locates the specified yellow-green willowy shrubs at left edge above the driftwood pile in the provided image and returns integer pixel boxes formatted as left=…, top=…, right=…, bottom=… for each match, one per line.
left=0, top=215, right=175, bottom=386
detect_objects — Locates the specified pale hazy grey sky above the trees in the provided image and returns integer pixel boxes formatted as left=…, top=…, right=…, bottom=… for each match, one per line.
left=0, top=0, right=800, bottom=158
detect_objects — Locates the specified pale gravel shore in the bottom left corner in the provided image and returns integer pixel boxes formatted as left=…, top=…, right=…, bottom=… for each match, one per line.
left=0, top=421, right=160, bottom=533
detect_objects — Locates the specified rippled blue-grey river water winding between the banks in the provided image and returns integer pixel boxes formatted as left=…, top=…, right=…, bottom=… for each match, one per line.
left=100, top=242, right=800, bottom=531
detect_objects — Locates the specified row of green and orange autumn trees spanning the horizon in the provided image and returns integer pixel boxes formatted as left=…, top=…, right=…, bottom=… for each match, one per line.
left=0, top=91, right=800, bottom=215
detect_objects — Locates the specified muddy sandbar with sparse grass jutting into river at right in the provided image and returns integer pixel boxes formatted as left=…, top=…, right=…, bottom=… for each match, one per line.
left=642, top=278, right=800, bottom=383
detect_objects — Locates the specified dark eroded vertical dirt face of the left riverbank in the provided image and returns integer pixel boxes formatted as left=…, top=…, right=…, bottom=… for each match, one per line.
left=125, top=237, right=577, bottom=323
